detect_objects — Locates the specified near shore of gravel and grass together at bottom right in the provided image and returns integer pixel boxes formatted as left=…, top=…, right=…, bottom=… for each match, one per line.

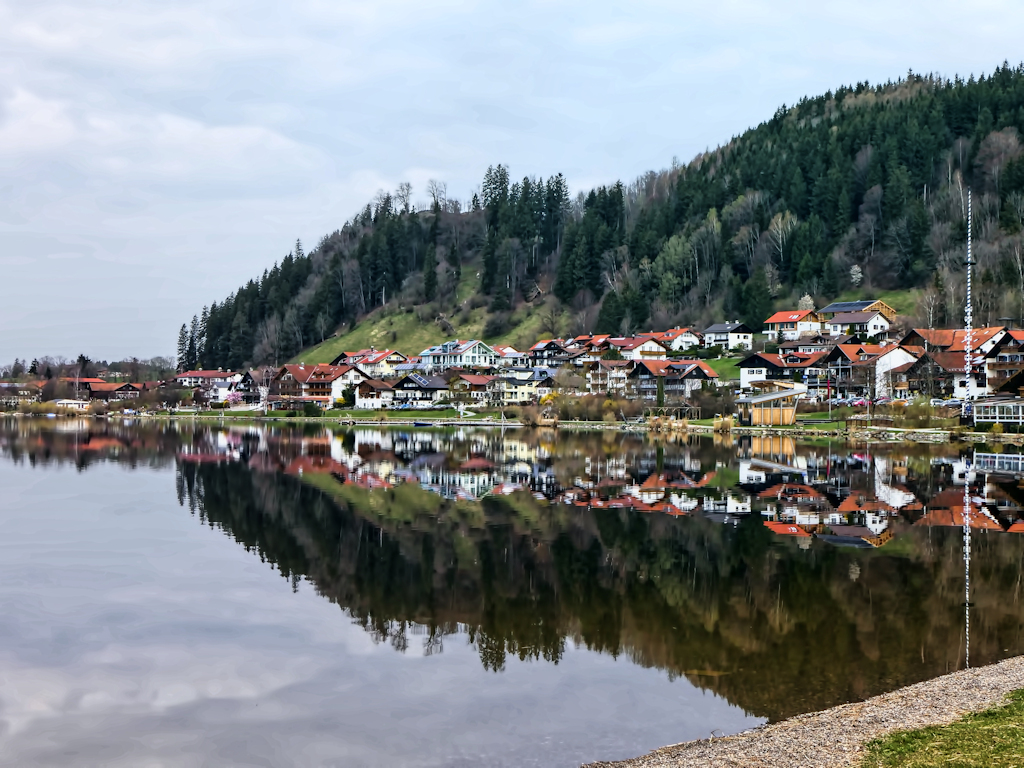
left=586, top=656, right=1024, bottom=768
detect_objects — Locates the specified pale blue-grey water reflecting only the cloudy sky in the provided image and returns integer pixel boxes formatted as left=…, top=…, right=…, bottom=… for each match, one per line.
left=0, top=462, right=763, bottom=766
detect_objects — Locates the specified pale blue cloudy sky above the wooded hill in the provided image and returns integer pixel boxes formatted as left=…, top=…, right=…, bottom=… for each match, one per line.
left=0, top=0, right=1024, bottom=361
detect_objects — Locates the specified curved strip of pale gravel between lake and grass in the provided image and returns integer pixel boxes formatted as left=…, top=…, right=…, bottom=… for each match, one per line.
left=586, top=656, right=1024, bottom=768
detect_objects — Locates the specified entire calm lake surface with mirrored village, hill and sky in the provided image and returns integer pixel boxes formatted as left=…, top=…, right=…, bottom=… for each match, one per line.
left=0, top=420, right=1024, bottom=766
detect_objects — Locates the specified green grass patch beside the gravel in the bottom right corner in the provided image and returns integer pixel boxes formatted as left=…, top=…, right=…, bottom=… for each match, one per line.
left=861, top=691, right=1024, bottom=768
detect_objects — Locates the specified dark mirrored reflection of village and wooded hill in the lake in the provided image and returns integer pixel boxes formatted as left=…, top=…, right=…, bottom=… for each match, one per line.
left=5, top=417, right=1024, bottom=719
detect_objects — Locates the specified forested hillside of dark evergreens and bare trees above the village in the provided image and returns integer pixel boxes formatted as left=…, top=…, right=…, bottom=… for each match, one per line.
left=178, top=66, right=1024, bottom=368
